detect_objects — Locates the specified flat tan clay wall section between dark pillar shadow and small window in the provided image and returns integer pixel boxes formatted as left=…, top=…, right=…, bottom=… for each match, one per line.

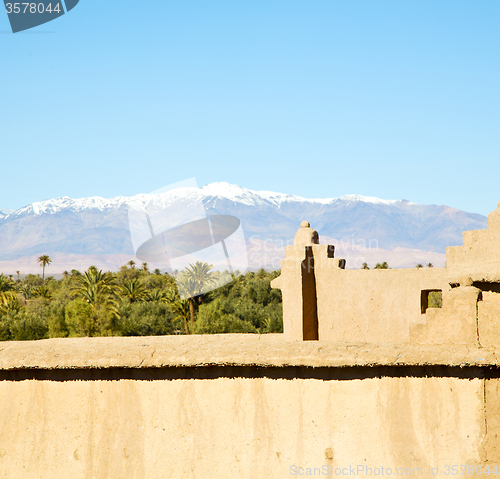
left=315, top=262, right=450, bottom=343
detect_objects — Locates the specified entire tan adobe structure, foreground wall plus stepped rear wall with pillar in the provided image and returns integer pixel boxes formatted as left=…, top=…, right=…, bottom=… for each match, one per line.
left=0, top=204, right=500, bottom=479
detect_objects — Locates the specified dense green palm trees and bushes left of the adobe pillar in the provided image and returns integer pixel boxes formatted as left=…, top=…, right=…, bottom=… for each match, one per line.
left=0, top=258, right=283, bottom=341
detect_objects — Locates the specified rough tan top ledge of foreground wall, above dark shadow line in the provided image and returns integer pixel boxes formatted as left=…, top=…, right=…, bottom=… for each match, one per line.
left=0, top=334, right=500, bottom=372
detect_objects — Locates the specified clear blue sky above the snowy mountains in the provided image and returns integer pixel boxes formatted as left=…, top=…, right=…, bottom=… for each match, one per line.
left=0, top=0, right=500, bottom=214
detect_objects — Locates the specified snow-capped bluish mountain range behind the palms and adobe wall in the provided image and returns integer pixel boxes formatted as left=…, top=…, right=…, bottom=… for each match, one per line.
left=0, top=183, right=487, bottom=272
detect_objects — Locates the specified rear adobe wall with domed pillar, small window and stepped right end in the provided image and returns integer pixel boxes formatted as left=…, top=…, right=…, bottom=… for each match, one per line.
left=272, top=203, right=500, bottom=348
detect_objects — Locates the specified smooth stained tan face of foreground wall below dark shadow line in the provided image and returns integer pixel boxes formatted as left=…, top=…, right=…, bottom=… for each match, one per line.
left=0, top=377, right=485, bottom=479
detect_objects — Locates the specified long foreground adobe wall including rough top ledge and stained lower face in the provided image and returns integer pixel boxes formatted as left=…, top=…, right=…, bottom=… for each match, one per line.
left=0, top=335, right=500, bottom=479
